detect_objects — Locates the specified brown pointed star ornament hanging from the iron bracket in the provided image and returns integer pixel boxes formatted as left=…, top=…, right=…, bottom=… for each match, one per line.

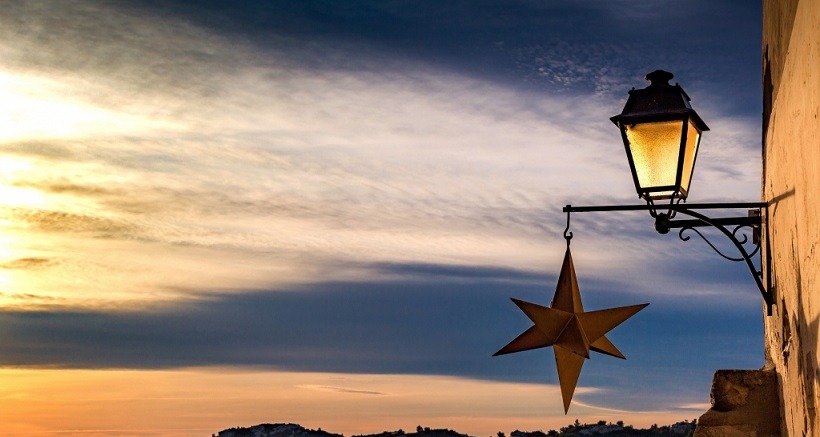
left=493, top=245, right=649, bottom=414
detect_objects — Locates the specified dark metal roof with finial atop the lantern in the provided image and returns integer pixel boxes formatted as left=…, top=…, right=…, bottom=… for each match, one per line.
left=610, top=70, right=709, bottom=132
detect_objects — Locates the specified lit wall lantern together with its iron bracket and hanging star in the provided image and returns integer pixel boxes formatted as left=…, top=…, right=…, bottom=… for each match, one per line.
left=495, top=70, right=774, bottom=413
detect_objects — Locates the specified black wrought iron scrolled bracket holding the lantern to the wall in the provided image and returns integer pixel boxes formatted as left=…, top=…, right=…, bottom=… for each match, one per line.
left=563, top=202, right=774, bottom=316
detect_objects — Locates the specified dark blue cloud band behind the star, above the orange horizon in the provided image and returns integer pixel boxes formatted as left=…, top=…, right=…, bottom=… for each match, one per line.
left=0, top=266, right=759, bottom=408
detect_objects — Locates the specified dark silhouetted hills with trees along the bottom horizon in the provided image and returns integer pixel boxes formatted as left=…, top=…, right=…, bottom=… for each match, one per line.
left=213, top=420, right=696, bottom=437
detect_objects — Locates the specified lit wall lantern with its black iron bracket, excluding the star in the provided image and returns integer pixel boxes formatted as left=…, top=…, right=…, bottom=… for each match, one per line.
left=564, top=70, right=774, bottom=315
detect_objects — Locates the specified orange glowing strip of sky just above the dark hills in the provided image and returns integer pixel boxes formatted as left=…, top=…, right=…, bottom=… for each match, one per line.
left=0, top=368, right=699, bottom=437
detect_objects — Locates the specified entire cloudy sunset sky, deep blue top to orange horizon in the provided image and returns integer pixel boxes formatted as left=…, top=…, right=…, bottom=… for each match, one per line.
left=0, top=0, right=763, bottom=436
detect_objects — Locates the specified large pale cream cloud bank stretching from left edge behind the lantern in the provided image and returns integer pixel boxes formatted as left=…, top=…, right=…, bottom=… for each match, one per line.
left=0, top=3, right=759, bottom=320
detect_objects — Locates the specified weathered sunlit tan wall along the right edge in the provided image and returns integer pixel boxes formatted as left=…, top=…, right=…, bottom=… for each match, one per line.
left=763, top=0, right=820, bottom=436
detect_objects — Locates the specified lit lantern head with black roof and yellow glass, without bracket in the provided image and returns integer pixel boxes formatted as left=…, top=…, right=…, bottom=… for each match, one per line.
left=610, top=70, right=709, bottom=204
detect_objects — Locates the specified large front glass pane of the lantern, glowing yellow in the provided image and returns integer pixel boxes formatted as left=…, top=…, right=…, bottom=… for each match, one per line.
left=624, top=120, right=694, bottom=198
